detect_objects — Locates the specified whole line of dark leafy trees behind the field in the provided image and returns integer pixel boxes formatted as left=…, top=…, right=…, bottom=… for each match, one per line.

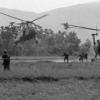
left=0, top=24, right=90, bottom=56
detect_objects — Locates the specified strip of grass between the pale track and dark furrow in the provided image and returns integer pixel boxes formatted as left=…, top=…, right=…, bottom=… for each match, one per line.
left=0, top=61, right=100, bottom=79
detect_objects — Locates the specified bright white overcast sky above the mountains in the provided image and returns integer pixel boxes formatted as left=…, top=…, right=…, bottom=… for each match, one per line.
left=0, top=0, right=99, bottom=13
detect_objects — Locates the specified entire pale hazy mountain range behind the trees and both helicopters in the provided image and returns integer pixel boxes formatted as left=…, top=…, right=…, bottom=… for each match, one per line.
left=0, top=2, right=100, bottom=41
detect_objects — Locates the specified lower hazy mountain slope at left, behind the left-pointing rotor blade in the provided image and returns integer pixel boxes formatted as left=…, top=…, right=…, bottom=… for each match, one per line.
left=0, top=8, right=38, bottom=26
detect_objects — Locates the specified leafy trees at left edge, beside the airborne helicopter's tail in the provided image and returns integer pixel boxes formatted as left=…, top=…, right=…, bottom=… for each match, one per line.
left=0, top=22, right=18, bottom=55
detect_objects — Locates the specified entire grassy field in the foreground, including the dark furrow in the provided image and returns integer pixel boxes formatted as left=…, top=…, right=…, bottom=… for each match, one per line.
left=0, top=61, right=100, bottom=100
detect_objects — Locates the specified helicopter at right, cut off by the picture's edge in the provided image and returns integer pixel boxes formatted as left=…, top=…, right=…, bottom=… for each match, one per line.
left=62, top=23, right=100, bottom=59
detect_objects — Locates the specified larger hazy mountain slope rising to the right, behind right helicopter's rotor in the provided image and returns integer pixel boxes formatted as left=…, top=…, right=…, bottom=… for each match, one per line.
left=38, top=2, right=100, bottom=41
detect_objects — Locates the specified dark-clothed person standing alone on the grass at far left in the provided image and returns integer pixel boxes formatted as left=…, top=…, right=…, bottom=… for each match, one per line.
left=2, top=50, right=10, bottom=71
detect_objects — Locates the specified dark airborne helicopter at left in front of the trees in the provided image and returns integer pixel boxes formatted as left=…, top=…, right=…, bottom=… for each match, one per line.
left=0, top=12, right=48, bottom=45
